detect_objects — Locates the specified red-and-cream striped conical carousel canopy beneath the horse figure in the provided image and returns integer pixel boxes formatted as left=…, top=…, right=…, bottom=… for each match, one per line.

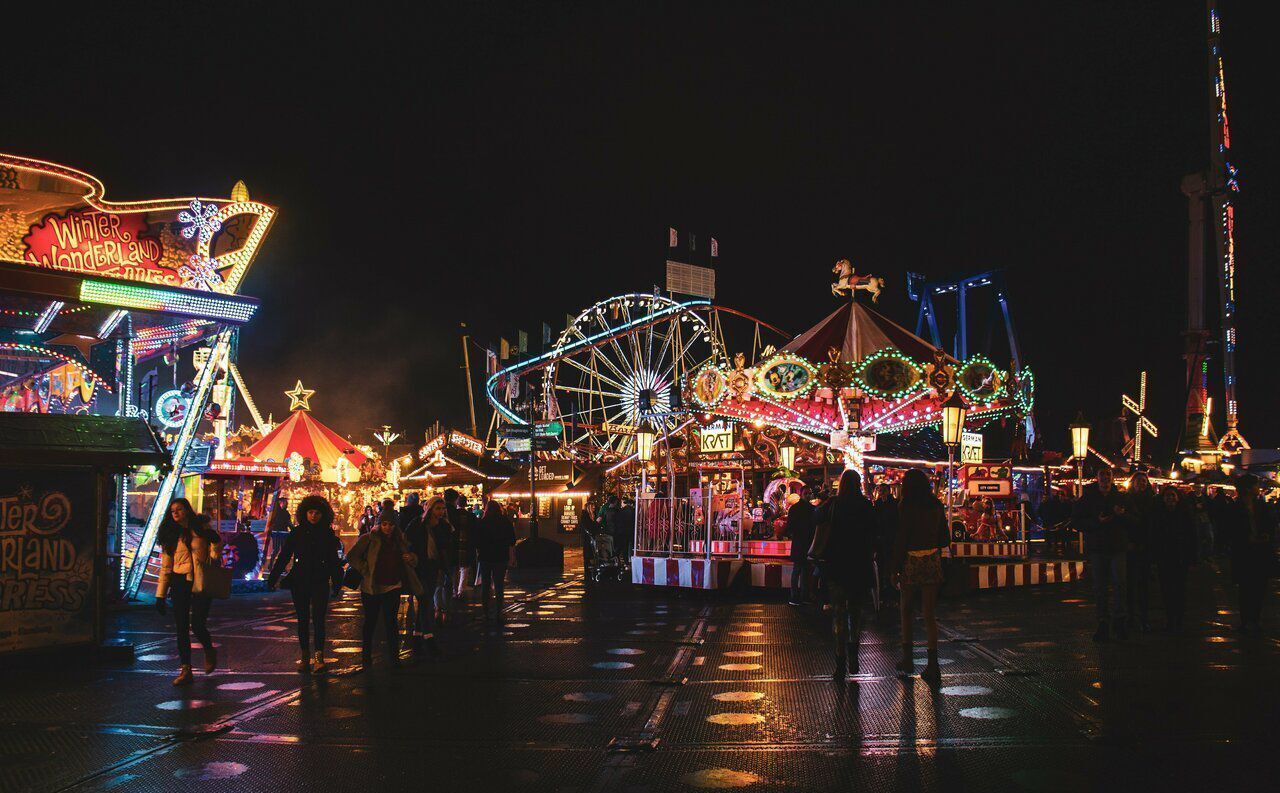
left=782, top=301, right=955, bottom=363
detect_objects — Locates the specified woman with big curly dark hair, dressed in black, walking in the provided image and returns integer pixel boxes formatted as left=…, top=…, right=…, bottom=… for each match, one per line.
left=266, top=495, right=342, bottom=674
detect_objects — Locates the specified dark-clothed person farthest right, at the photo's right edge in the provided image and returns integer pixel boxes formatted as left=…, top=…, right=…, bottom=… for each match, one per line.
left=1222, top=473, right=1276, bottom=633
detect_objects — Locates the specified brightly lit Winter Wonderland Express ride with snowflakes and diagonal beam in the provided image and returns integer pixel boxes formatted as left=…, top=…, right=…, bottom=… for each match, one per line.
left=0, top=155, right=275, bottom=596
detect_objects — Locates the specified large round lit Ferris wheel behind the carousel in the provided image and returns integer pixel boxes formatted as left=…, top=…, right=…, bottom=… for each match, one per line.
left=541, top=294, right=726, bottom=459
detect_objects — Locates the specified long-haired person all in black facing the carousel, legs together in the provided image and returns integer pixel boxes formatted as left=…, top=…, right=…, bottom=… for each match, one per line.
left=814, top=469, right=876, bottom=680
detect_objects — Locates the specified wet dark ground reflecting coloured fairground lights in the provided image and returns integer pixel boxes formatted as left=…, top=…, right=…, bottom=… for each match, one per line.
left=0, top=557, right=1280, bottom=793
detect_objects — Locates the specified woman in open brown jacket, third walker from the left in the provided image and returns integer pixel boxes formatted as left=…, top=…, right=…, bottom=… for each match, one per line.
left=347, top=510, right=422, bottom=671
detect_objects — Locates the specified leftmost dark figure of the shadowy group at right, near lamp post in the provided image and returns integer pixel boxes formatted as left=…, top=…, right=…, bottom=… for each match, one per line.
left=1071, top=468, right=1129, bottom=642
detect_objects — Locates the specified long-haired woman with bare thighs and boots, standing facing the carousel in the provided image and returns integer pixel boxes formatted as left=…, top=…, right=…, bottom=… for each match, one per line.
left=893, top=468, right=951, bottom=683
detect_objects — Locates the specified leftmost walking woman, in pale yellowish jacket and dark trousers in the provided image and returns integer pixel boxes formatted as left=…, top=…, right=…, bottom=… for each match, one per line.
left=156, top=499, right=223, bottom=686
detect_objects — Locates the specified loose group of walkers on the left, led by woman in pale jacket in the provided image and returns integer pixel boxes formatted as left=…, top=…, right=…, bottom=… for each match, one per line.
left=156, top=490, right=516, bottom=686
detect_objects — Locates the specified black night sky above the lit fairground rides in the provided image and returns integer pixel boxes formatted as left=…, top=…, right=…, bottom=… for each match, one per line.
left=0, top=0, right=1280, bottom=457
